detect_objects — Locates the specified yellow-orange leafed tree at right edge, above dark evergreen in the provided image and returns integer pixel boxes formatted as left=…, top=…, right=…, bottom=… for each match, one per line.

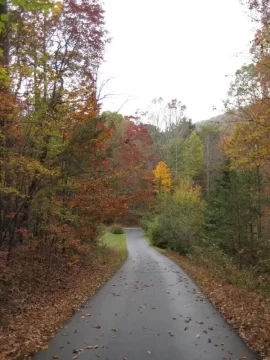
left=223, top=24, right=270, bottom=242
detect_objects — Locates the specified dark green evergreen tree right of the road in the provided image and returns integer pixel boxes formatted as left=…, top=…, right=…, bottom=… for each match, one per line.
left=204, top=164, right=267, bottom=268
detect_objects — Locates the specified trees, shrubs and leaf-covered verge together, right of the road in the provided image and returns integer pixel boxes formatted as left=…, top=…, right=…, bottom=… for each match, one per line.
left=141, top=2, right=270, bottom=358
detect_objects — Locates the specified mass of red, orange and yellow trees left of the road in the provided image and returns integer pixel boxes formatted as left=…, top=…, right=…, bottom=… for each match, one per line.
left=0, top=0, right=157, bottom=358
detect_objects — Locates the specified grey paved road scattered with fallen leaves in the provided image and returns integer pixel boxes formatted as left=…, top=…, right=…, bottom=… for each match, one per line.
left=34, top=229, right=257, bottom=360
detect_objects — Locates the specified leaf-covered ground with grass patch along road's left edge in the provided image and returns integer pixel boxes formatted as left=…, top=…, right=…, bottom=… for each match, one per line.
left=0, top=233, right=127, bottom=360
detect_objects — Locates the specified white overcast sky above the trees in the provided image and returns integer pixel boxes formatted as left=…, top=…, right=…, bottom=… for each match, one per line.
left=100, top=0, right=254, bottom=121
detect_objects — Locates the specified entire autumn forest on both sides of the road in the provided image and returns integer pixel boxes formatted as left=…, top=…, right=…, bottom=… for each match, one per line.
left=0, top=0, right=270, bottom=358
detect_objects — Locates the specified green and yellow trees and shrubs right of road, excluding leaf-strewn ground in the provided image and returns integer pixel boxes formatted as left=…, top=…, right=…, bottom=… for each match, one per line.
left=142, top=1, right=270, bottom=282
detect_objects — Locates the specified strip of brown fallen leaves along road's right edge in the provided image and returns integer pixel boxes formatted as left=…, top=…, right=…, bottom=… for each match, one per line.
left=158, top=249, right=270, bottom=360
